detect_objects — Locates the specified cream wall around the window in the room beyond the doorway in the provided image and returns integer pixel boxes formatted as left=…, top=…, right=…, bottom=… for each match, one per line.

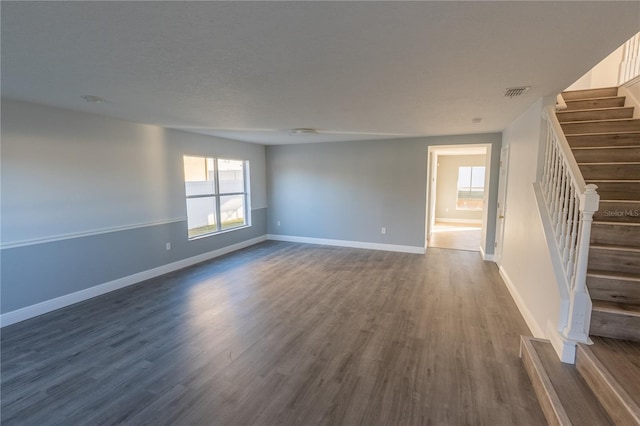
left=436, top=155, right=486, bottom=223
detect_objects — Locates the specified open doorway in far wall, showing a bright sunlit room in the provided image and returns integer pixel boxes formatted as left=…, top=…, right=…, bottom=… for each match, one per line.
left=426, top=144, right=490, bottom=252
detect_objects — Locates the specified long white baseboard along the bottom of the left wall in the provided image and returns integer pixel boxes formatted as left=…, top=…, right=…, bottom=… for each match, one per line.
left=0, top=235, right=267, bottom=327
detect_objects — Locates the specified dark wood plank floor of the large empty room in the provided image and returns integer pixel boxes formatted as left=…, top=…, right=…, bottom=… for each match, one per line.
left=1, top=241, right=546, bottom=426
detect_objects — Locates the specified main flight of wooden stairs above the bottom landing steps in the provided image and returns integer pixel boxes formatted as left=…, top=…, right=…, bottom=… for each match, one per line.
left=557, top=87, right=640, bottom=341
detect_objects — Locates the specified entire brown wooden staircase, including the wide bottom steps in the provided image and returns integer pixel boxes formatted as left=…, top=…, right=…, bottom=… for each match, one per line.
left=521, top=88, right=640, bottom=426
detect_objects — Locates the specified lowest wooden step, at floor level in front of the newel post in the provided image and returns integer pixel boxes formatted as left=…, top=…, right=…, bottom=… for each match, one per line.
left=520, top=336, right=613, bottom=425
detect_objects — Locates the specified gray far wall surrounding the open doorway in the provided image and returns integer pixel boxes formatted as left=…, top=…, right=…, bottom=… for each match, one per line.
left=267, top=134, right=501, bottom=250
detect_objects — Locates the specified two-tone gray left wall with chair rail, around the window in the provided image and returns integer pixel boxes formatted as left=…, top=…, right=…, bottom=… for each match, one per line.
left=0, top=99, right=267, bottom=313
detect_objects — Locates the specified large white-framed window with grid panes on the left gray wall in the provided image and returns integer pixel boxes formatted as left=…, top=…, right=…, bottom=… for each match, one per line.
left=184, top=155, right=249, bottom=239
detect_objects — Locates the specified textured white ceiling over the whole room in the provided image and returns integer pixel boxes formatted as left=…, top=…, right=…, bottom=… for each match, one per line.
left=1, top=1, right=640, bottom=144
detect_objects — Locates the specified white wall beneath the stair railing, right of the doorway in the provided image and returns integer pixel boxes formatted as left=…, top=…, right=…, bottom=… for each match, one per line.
left=500, top=100, right=560, bottom=337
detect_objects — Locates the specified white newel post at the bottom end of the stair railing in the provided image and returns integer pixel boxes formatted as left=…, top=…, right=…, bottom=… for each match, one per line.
left=564, top=185, right=600, bottom=342
